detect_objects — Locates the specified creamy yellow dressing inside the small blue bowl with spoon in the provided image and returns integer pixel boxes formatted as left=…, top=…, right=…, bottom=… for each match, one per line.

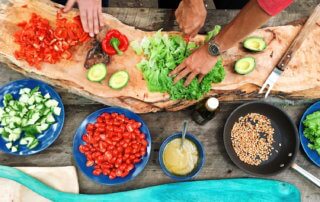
left=163, top=138, right=199, bottom=175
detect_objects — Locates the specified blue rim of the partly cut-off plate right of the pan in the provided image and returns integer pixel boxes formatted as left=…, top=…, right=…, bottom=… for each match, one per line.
left=299, top=101, right=320, bottom=167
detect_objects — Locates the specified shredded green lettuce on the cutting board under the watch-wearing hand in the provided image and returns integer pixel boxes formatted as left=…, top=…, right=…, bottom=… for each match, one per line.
left=131, top=27, right=225, bottom=100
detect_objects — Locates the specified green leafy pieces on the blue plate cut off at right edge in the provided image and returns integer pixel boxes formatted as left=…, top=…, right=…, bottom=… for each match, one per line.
left=303, top=111, right=320, bottom=155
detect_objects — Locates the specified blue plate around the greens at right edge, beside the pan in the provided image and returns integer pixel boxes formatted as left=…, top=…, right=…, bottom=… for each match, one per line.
left=299, top=101, right=320, bottom=167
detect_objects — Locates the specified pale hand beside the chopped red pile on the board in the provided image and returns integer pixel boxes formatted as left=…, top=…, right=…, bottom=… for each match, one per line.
left=63, top=0, right=103, bottom=37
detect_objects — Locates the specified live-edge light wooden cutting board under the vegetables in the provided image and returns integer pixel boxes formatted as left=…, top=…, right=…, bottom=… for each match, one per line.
left=0, top=0, right=320, bottom=113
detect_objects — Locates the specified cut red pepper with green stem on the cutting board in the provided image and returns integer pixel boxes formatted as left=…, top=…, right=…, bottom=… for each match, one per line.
left=102, top=29, right=129, bottom=56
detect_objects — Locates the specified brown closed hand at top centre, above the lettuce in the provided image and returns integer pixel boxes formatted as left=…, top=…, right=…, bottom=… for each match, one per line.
left=175, top=0, right=207, bottom=37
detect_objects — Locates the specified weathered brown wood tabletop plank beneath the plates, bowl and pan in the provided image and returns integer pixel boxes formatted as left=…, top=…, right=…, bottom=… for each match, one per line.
left=0, top=104, right=320, bottom=201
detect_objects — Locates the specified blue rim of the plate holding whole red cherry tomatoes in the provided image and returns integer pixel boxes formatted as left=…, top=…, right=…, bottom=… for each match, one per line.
left=72, top=106, right=152, bottom=186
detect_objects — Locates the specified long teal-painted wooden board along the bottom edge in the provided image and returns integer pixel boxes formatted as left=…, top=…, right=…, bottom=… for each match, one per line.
left=0, top=166, right=300, bottom=202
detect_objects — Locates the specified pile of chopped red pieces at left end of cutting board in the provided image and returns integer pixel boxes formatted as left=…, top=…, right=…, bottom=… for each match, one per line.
left=14, top=12, right=89, bottom=68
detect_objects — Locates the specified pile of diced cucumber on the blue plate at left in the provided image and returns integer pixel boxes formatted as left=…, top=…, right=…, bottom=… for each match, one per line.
left=0, top=87, right=62, bottom=152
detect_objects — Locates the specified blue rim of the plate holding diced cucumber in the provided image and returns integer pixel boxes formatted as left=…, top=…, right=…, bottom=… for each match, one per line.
left=0, top=78, right=65, bottom=156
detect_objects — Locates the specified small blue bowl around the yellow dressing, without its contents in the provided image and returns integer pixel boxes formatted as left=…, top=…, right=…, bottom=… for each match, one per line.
left=159, top=132, right=205, bottom=181
